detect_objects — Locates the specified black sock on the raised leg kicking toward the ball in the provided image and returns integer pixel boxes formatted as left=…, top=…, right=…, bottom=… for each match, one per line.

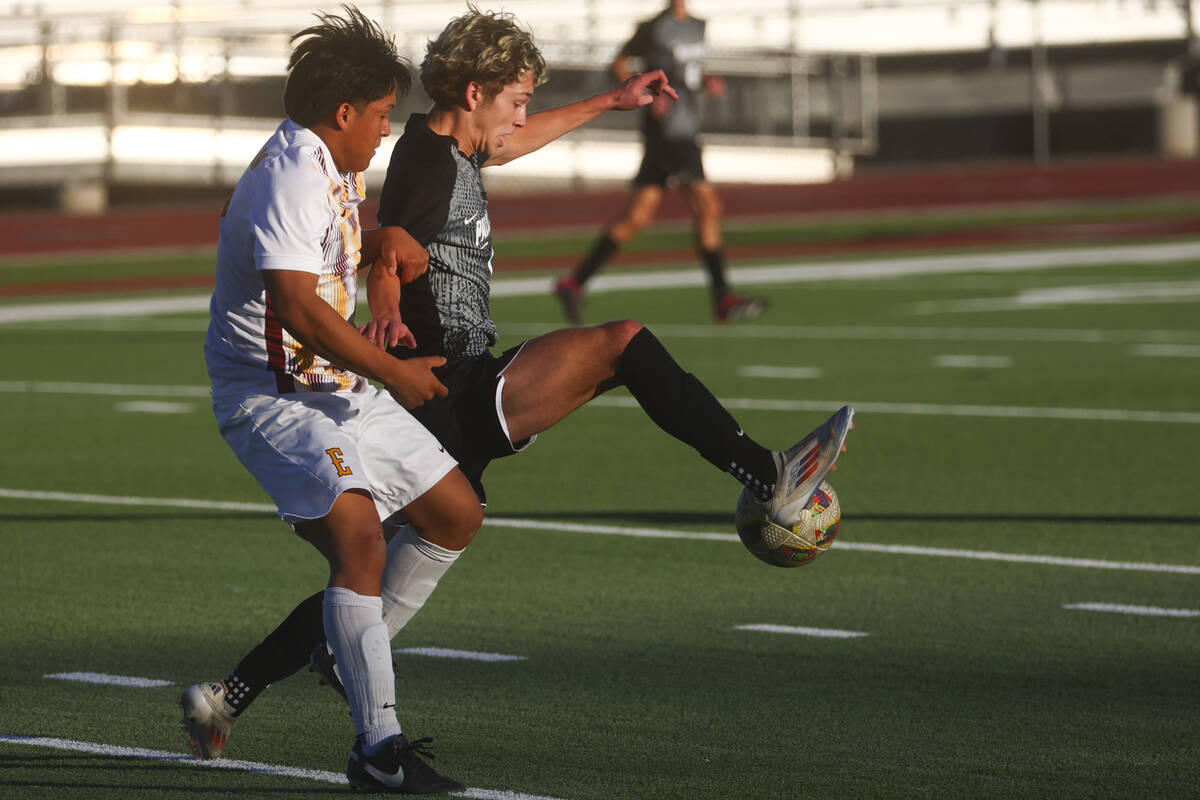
left=617, top=327, right=775, bottom=499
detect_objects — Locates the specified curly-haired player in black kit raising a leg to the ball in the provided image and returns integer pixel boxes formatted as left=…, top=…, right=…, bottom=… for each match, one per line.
left=180, top=3, right=853, bottom=772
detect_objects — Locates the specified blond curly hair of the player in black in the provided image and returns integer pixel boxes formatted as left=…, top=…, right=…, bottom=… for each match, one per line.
left=421, top=4, right=547, bottom=108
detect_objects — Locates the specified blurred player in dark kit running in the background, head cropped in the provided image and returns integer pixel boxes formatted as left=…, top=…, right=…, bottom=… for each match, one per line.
left=554, top=0, right=767, bottom=325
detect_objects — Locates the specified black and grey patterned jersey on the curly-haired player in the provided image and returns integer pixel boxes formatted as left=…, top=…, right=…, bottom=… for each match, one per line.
left=379, top=114, right=497, bottom=361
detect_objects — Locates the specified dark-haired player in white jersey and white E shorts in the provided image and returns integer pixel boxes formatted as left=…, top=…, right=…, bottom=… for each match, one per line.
left=181, top=6, right=472, bottom=794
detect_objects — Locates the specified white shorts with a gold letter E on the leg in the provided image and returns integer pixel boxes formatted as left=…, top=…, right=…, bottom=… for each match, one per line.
left=212, top=386, right=456, bottom=524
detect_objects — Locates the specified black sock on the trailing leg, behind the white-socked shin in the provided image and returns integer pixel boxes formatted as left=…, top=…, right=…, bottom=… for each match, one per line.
left=226, top=591, right=325, bottom=716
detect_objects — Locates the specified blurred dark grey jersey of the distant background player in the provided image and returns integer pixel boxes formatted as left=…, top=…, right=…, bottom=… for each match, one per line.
left=620, top=8, right=704, bottom=140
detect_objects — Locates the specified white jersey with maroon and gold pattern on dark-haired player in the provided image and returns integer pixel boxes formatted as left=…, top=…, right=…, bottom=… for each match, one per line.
left=204, top=120, right=367, bottom=397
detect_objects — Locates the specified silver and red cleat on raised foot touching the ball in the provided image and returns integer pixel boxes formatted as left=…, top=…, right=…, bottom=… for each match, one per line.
left=766, top=405, right=854, bottom=528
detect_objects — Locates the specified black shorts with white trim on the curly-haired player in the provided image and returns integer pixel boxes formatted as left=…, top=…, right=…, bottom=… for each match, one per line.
left=412, top=343, right=533, bottom=503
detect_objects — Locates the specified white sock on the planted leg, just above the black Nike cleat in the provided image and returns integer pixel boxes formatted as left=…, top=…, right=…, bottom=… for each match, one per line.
left=322, top=587, right=400, bottom=753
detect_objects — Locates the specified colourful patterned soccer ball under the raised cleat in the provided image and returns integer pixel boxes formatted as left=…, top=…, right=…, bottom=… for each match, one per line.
left=733, top=481, right=841, bottom=566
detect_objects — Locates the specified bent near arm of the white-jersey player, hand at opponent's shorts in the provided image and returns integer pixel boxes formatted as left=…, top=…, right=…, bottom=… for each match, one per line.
left=263, top=270, right=449, bottom=408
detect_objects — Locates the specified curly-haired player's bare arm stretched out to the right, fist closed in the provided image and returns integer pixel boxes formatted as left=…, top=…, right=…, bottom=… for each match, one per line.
left=484, top=70, right=679, bottom=167
